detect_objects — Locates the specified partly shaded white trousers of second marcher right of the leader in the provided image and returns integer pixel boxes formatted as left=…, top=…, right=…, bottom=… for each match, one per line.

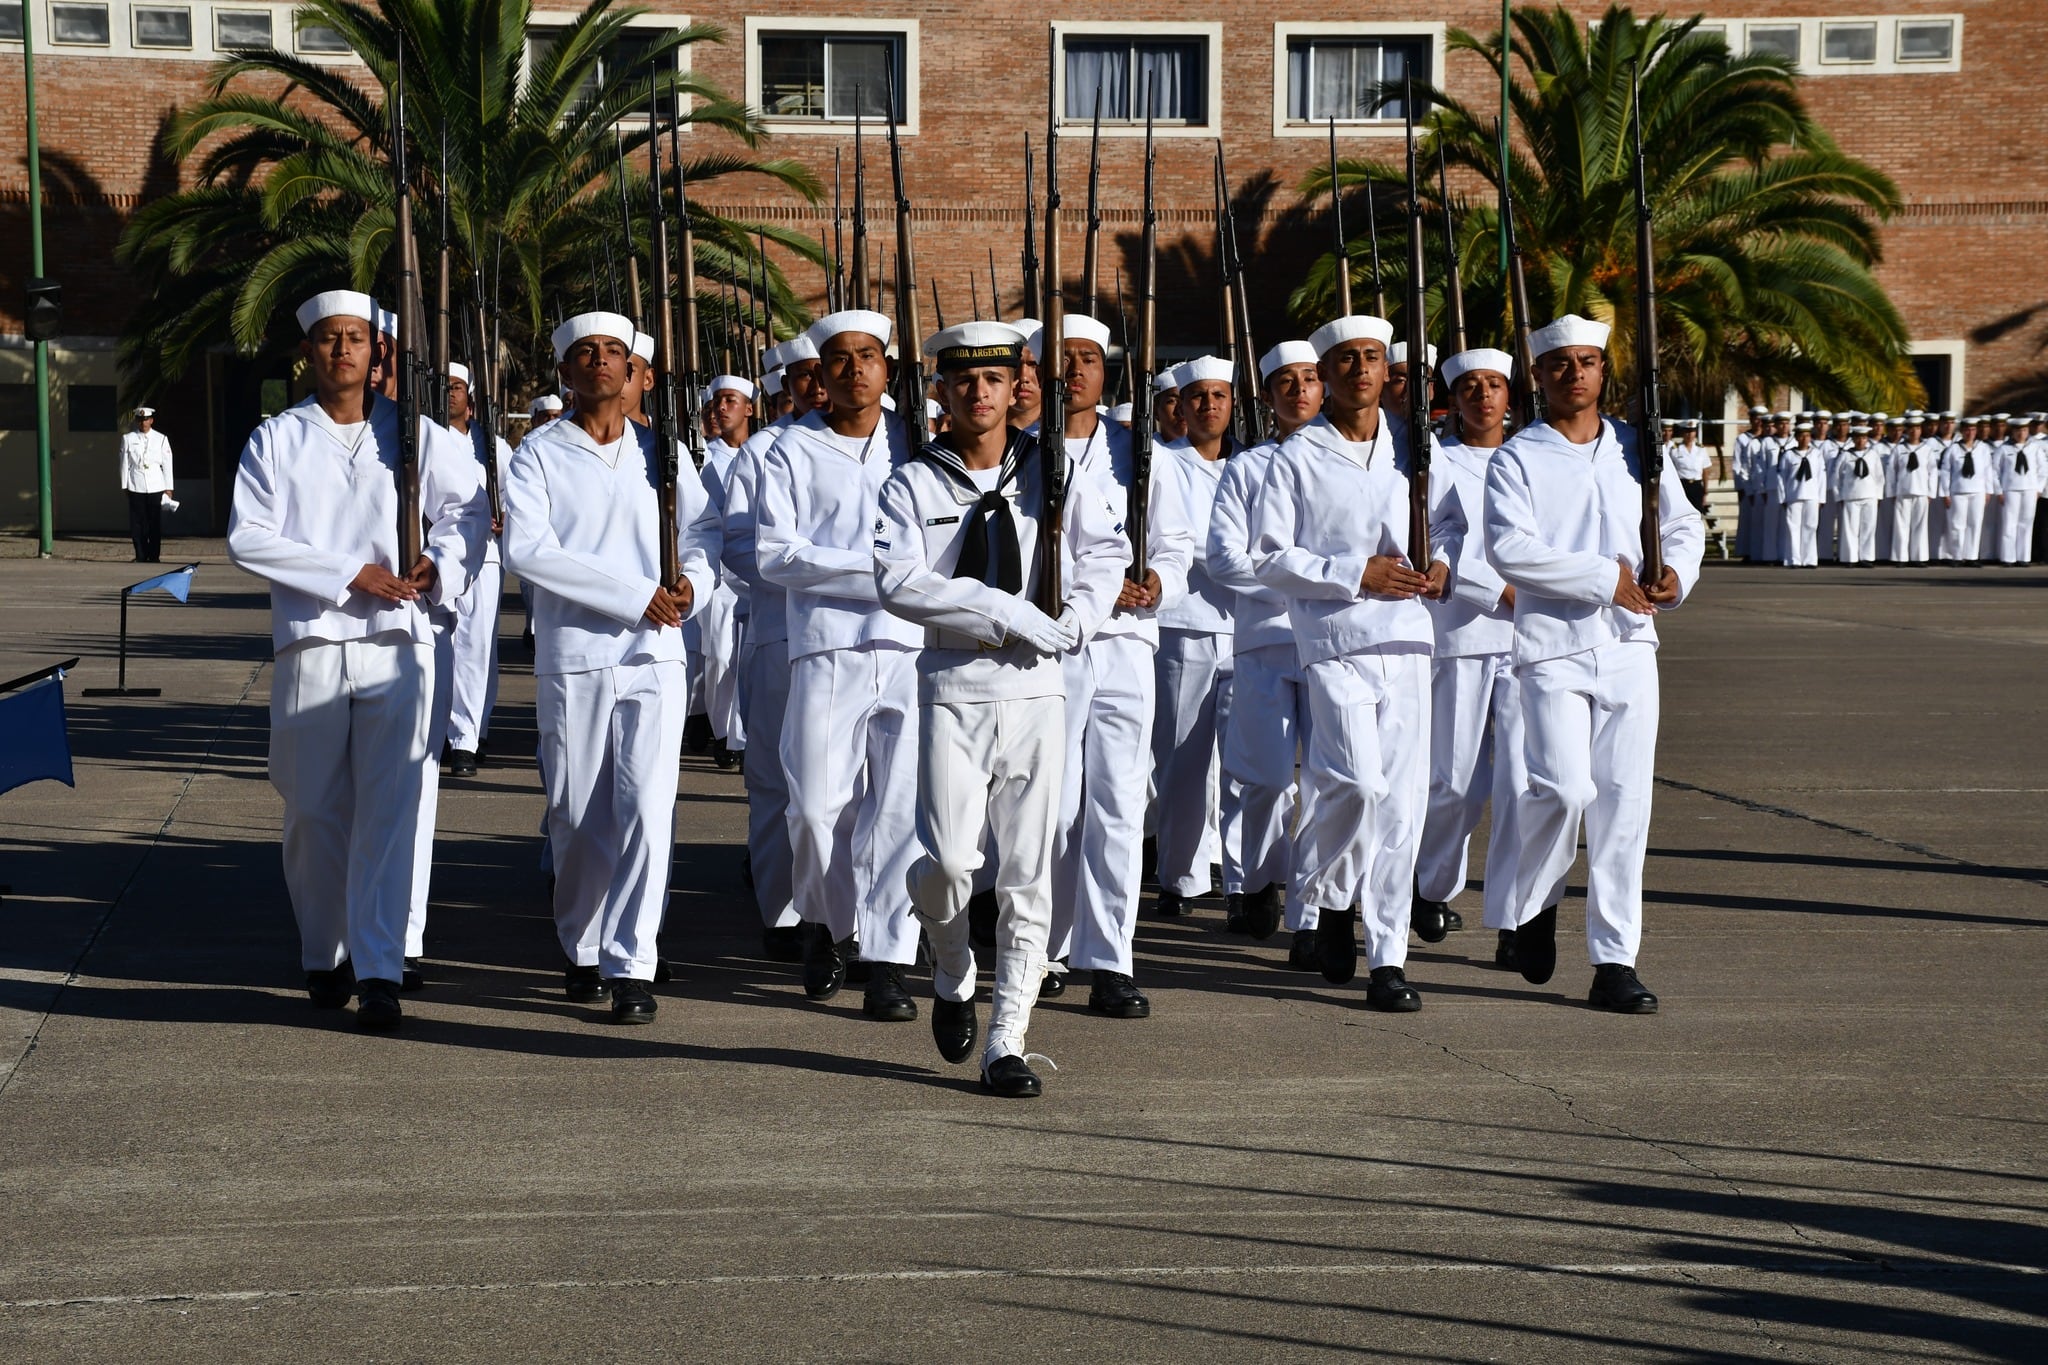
left=1153, top=630, right=1245, bottom=896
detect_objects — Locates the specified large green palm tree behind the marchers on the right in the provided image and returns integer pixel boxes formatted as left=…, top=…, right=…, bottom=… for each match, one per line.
left=1290, top=6, right=1919, bottom=411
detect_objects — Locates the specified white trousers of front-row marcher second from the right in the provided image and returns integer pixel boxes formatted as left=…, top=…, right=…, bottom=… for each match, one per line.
left=1303, top=651, right=1430, bottom=968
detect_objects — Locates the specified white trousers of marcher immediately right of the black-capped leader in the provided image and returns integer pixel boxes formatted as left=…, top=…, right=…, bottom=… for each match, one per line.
left=1051, top=636, right=1155, bottom=976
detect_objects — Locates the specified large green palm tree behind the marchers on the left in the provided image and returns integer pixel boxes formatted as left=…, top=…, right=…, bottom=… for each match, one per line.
left=119, top=0, right=821, bottom=403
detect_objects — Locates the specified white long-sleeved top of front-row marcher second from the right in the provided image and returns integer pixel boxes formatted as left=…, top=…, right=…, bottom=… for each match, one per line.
left=1251, top=417, right=1450, bottom=665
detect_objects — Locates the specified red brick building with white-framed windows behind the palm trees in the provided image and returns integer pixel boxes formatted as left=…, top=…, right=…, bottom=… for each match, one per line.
left=0, top=0, right=2048, bottom=530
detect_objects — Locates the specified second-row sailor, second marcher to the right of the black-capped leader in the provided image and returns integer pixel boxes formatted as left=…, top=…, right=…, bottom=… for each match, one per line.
left=1155, top=356, right=1245, bottom=921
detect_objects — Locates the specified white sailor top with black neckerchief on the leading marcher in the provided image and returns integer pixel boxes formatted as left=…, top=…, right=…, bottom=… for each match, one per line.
left=874, top=432, right=1130, bottom=702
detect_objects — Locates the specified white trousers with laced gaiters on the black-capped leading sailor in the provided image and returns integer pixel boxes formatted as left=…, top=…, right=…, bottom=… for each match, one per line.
left=909, top=696, right=1067, bottom=1062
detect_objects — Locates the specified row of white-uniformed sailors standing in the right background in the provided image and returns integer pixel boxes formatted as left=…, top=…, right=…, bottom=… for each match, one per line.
left=1728, top=407, right=2048, bottom=569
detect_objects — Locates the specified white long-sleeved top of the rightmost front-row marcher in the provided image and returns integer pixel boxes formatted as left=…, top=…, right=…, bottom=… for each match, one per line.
left=1485, top=420, right=1706, bottom=665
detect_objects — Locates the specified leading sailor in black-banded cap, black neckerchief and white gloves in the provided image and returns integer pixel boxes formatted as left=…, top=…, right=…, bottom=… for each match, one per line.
left=874, top=321, right=1130, bottom=1097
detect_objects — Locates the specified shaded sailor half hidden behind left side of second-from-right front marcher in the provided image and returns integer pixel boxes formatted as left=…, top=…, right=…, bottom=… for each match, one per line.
left=1208, top=342, right=1323, bottom=972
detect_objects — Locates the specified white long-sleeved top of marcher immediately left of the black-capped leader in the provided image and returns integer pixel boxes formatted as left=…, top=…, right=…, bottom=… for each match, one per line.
left=756, top=411, right=924, bottom=659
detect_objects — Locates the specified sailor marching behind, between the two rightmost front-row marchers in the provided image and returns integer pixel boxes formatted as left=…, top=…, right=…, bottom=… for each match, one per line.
left=1411, top=350, right=1528, bottom=966
